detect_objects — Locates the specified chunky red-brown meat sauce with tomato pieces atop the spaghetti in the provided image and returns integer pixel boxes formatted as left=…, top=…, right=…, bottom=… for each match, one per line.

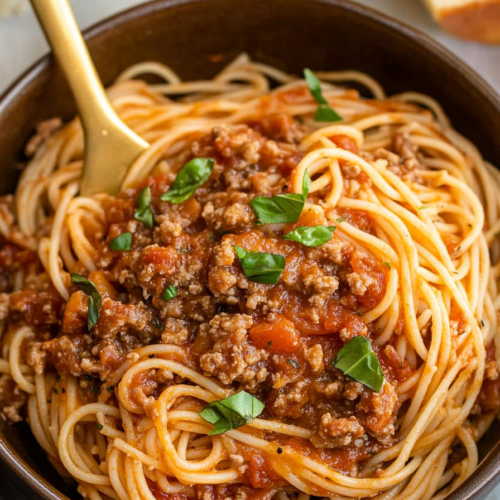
left=0, top=113, right=492, bottom=500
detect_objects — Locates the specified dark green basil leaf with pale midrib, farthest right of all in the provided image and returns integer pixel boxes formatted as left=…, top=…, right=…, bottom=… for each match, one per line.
left=332, top=336, right=384, bottom=392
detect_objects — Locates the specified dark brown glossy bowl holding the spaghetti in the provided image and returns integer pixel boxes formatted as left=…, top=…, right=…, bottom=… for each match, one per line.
left=0, top=0, right=500, bottom=500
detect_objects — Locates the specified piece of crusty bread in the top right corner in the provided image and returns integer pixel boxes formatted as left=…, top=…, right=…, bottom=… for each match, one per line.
left=425, top=0, right=500, bottom=44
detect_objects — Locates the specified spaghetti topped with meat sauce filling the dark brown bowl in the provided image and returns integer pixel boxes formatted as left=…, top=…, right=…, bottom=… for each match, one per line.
left=0, top=55, right=500, bottom=500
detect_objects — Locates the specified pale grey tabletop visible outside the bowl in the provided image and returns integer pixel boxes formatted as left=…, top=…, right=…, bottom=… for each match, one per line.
left=0, top=0, right=500, bottom=500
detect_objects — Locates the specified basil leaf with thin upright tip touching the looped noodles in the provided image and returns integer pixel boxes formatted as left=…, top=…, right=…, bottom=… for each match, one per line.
left=250, top=170, right=311, bottom=224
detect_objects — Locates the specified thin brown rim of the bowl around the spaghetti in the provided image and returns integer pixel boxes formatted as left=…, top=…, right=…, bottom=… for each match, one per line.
left=0, top=0, right=500, bottom=500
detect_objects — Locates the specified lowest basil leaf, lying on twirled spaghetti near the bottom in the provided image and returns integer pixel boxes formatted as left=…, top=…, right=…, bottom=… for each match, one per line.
left=200, top=391, right=264, bottom=436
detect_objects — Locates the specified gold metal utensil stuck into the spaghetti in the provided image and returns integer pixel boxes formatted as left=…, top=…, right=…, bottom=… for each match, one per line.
left=31, top=0, right=149, bottom=196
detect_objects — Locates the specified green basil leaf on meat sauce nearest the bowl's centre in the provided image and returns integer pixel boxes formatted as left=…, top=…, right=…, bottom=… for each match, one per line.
left=234, top=246, right=286, bottom=285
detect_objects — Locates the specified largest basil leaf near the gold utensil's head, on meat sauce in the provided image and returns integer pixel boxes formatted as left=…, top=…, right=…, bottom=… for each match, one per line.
left=160, top=158, right=215, bottom=204
